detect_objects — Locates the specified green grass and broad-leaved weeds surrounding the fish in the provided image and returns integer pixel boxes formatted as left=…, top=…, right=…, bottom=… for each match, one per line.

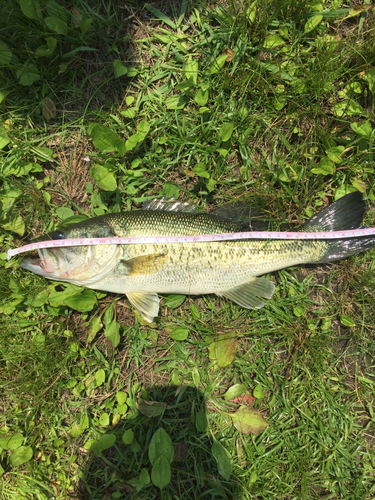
left=0, top=0, right=375, bottom=500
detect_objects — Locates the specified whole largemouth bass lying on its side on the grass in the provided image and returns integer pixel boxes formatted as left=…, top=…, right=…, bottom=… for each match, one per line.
left=20, top=191, right=375, bottom=323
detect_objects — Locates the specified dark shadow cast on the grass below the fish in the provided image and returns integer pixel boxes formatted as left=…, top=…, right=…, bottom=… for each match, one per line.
left=78, top=386, right=240, bottom=500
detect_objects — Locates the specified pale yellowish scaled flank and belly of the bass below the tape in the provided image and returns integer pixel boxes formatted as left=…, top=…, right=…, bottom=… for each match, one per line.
left=90, top=240, right=325, bottom=295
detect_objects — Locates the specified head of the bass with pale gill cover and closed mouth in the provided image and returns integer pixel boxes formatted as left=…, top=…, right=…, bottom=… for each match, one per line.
left=20, top=217, right=121, bottom=286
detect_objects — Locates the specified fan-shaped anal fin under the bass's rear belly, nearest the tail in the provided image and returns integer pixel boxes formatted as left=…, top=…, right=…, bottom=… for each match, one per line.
left=217, top=278, right=275, bottom=309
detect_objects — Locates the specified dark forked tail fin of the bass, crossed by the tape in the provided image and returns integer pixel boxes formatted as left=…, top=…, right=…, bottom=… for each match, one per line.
left=299, top=191, right=375, bottom=264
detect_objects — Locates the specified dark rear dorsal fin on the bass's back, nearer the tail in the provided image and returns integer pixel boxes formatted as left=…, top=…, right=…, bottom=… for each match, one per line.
left=210, top=201, right=268, bottom=231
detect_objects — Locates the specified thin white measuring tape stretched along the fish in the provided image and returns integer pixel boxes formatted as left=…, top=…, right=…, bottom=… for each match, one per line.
left=7, top=227, right=375, bottom=260
